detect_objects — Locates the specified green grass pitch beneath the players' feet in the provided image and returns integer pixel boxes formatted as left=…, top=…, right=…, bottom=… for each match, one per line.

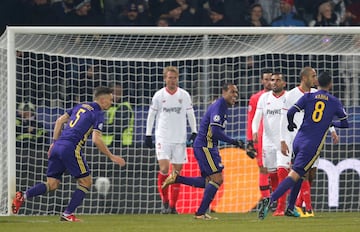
left=0, top=212, right=360, bottom=232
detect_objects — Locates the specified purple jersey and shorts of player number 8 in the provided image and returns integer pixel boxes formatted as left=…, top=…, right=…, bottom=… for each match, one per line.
left=288, top=90, right=347, bottom=174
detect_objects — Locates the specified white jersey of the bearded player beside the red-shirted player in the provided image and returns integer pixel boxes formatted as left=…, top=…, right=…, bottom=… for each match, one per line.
left=253, top=91, right=286, bottom=149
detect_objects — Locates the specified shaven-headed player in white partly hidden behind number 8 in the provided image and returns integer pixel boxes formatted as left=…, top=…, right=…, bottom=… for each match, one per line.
left=280, top=67, right=339, bottom=217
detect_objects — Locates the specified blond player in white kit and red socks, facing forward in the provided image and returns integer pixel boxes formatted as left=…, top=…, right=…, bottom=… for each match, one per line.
left=145, top=66, right=197, bottom=214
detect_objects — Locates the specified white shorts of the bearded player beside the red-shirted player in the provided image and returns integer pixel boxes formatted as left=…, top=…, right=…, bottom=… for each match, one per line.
left=263, top=146, right=291, bottom=172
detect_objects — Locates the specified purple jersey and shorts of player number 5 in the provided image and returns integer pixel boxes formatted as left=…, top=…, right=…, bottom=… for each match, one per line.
left=47, top=102, right=104, bottom=179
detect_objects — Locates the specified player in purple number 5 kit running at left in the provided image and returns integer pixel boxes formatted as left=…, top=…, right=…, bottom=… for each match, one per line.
left=12, top=87, right=125, bottom=222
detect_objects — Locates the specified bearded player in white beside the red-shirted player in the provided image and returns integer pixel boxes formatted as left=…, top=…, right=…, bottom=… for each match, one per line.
left=252, top=73, right=291, bottom=216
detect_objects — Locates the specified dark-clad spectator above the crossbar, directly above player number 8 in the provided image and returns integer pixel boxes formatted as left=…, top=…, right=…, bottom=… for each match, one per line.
left=309, top=1, right=341, bottom=27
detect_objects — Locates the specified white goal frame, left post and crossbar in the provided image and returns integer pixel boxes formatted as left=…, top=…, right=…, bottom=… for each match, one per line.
left=1, top=26, right=360, bottom=215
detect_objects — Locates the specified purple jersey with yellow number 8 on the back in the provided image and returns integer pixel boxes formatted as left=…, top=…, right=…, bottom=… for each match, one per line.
left=296, top=90, right=347, bottom=149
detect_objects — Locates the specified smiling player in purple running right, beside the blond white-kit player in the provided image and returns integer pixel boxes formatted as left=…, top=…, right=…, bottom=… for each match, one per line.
left=162, top=83, right=248, bottom=220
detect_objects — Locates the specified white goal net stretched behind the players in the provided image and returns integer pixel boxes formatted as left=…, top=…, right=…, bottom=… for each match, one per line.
left=0, top=27, right=360, bottom=215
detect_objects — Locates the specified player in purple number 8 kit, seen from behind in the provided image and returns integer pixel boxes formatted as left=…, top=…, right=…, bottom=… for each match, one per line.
left=258, top=72, right=349, bottom=220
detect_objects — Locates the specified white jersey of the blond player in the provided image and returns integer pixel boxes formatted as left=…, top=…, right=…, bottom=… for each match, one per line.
left=150, top=87, right=193, bottom=143
